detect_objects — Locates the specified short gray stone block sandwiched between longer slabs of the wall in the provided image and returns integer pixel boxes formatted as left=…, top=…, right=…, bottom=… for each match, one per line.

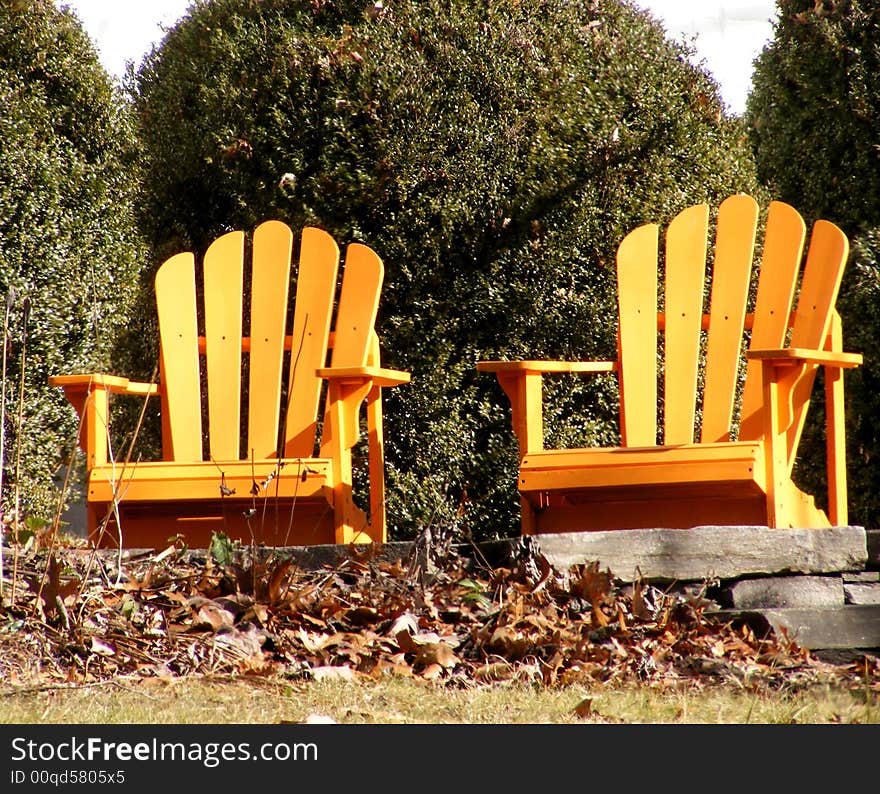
left=724, top=576, right=844, bottom=609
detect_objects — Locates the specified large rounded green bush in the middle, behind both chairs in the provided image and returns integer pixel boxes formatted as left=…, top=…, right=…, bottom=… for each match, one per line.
left=130, top=0, right=756, bottom=537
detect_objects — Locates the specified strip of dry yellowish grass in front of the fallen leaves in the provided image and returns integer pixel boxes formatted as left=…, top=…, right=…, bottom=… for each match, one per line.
left=0, top=678, right=880, bottom=724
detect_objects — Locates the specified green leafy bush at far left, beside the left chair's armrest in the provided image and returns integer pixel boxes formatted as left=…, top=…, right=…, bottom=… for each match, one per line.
left=0, top=0, right=144, bottom=518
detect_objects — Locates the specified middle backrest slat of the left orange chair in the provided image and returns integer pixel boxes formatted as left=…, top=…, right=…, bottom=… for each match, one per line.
left=244, top=221, right=293, bottom=460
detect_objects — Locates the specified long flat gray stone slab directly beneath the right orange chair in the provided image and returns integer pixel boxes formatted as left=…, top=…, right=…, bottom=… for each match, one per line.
left=531, top=526, right=867, bottom=581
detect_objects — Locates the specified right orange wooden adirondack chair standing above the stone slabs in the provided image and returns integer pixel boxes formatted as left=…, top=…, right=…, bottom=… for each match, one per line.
left=477, top=195, right=862, bottom=534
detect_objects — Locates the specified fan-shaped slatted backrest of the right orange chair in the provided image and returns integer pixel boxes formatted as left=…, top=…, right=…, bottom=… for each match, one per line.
left=617, top=195, right=849, bottom=458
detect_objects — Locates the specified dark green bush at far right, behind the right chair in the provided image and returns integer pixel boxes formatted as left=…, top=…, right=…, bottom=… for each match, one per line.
left=746, top=0, right=880, bottom=526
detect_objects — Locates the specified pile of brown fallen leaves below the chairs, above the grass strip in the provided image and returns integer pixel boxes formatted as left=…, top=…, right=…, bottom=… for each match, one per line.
left=0, top=546, right=880, bottom=688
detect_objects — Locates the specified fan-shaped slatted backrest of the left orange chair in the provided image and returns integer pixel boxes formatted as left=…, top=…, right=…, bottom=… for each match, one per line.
left=155, top=221, right=383, bottom=463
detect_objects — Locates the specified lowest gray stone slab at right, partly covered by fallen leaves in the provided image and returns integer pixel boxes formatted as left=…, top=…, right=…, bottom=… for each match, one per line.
left=707, top=605, right=880, bottom=649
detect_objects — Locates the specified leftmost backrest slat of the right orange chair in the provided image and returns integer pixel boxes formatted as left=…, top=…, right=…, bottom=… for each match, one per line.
left=617, top=223, right=659, bottom=447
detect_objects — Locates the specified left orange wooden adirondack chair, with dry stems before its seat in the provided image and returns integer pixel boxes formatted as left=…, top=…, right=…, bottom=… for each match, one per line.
left=50, top=221, right=409, bottom=547
